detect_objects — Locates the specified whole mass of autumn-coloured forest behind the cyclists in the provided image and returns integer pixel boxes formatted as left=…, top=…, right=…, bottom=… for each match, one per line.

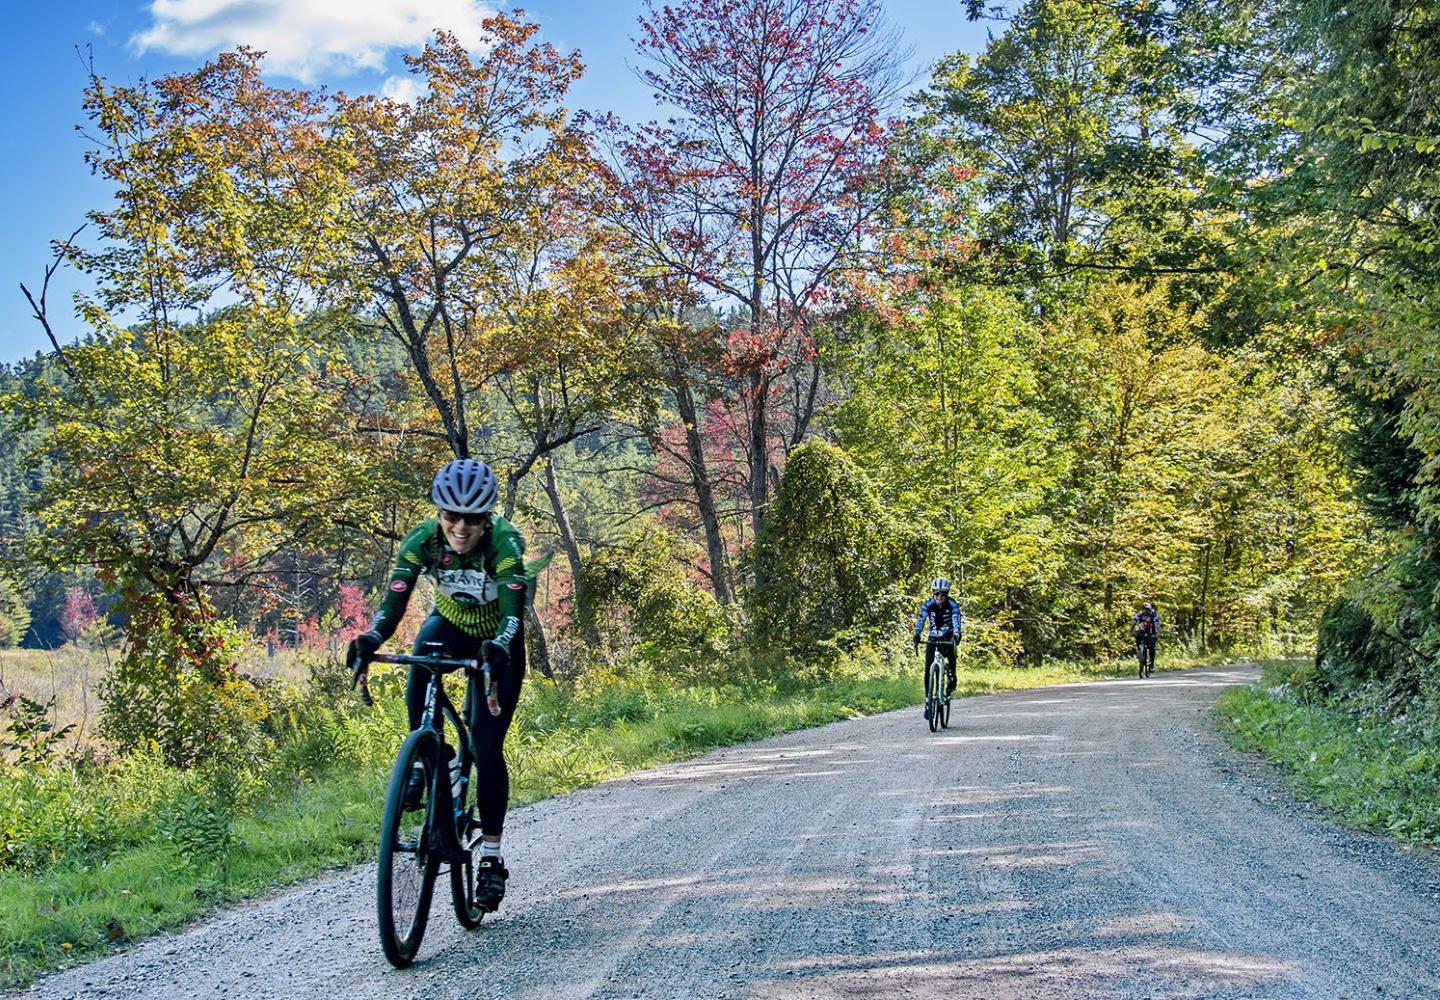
left=0, top=0, right=1440, bottom=974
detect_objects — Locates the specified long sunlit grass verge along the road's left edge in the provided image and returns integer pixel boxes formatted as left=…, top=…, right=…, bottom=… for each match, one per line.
left=0, top=654, right=1223, bottom=986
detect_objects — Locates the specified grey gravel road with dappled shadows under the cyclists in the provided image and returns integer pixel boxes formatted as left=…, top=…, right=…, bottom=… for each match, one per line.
left=20, top=667, right=1440, bottom=1000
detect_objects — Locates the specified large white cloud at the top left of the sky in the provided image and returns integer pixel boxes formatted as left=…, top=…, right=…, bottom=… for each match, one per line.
left=130, top=0, right=492, bottom=84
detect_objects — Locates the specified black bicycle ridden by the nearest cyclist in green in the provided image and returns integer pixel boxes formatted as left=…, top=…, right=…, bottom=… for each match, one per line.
left=361, top=643, right=500, bottom=968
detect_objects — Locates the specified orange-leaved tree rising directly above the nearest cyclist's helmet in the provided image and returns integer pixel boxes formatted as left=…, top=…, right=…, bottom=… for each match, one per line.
left=340, top=14, right=585, bottom=457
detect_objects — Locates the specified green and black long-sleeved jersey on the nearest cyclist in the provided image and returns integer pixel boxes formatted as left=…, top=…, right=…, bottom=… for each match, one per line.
left=370, top=516, right=526, bottom=653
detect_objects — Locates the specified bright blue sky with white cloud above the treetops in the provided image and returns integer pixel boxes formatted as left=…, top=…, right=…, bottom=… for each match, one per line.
left=0, top=0, right=985, bottom=362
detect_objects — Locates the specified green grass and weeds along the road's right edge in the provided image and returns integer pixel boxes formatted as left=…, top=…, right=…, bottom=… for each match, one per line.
left=1215, top=660, right=1440, bottom=846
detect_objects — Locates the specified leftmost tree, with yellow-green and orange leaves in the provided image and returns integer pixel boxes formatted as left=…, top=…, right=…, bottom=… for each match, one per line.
left=10, top=50, right=360, bottom=622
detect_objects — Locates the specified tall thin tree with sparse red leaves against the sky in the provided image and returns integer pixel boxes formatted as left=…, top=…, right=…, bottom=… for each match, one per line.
left=615, top=0, right=903, bottom=544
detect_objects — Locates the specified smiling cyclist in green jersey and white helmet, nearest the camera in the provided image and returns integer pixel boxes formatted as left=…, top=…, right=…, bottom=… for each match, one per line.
left=346, top=458, right=527, bottom=909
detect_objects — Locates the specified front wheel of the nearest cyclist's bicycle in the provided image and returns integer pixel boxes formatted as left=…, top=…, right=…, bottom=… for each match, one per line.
left=376, top=731, right=439, bottom=968
